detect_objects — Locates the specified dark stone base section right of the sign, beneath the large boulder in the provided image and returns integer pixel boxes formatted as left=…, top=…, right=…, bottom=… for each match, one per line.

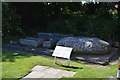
left=71, top=48, right=119, bottom=64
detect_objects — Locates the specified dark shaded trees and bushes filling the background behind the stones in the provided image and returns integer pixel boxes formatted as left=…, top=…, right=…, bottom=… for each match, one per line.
left=2, top=2, right=120, bottom=41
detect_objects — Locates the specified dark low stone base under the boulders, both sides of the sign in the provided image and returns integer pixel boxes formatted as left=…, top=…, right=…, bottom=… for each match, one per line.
left=2, top=44, right=120, bottom=65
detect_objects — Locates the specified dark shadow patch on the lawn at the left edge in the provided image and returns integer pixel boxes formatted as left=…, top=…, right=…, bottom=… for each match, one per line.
left=2, top=50, right=33, bottom=62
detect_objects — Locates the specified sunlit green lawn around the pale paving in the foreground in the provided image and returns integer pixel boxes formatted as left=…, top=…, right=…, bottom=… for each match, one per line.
left=2, top=50, right=118, bottom=78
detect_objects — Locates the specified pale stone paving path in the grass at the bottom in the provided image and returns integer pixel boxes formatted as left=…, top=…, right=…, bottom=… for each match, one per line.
left=21, top=66, right=76, bottom=80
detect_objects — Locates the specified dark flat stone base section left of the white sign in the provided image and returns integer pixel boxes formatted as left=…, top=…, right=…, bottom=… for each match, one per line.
left=2, top=44, right=53, bottom=56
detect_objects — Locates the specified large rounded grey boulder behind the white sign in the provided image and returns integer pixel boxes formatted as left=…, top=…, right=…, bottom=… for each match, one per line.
left=57, top=37, right=111, bottom=54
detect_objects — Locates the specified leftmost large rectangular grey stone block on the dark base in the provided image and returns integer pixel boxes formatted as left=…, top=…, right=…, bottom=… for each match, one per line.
left=20, top=38, right=45, bottom=47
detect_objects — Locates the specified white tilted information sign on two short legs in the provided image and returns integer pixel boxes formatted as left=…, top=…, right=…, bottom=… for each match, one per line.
left=52, top=46, right=72, bottom=66
